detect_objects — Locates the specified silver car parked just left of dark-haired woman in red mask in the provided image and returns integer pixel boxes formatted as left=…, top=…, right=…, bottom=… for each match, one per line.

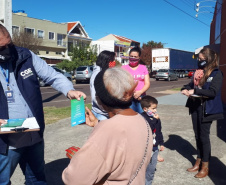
left=75, top=66, right=93, bottom=83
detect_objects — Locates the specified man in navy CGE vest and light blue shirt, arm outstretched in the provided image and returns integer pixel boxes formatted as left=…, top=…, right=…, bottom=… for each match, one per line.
left=0, top=24, right=86, bottom=185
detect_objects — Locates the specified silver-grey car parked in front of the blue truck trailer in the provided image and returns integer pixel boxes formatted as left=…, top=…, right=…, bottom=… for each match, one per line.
left=155, top=69, right=178, bottom=81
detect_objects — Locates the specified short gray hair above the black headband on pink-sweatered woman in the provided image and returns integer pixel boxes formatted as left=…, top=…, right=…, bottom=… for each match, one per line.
left=103, top=67, right=135, bottom=101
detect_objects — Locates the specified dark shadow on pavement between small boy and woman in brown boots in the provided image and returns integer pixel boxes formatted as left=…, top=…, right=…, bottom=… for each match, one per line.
left=164, top=135, right=196, bottom=164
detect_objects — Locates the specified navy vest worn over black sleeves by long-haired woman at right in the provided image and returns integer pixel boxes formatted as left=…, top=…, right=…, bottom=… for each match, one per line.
left=202, top=69, right=223, bottom=114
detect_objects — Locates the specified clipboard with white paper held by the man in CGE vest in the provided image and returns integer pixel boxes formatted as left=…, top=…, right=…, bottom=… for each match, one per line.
left=0, top=117, right=40, bottom=134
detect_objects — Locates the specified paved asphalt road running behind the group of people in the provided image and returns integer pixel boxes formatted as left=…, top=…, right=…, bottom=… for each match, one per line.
left=41, top=78, right=190, bottom=107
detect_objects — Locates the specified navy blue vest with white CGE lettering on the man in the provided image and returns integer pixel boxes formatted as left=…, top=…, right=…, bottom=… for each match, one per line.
left=0, top=47, right=45, bottom=153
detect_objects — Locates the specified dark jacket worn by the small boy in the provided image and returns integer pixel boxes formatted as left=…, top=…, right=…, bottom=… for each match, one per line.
left=141, top=112, right=164, bottom=146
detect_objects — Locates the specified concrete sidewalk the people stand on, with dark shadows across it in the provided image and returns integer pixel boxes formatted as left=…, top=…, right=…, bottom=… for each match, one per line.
left=12, top=93, right=226, bottom=185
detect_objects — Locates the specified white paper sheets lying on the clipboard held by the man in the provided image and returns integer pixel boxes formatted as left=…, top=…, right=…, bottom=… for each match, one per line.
left=1, top=117, right=40, bottom=132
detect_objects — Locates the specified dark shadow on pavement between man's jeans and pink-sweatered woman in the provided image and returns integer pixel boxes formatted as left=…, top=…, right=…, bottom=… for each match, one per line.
left=45, top=158, right=70, bottom=185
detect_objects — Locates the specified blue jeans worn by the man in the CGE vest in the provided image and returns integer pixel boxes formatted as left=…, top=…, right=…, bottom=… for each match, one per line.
left=0, top=141, right=47, bottom=185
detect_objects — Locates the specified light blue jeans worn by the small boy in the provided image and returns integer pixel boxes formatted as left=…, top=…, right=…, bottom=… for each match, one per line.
left=145, top=147, right=159, bottom=185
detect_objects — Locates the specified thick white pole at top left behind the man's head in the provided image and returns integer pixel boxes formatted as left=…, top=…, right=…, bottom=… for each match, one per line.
left=0, top=0, right=12, bottom=36
